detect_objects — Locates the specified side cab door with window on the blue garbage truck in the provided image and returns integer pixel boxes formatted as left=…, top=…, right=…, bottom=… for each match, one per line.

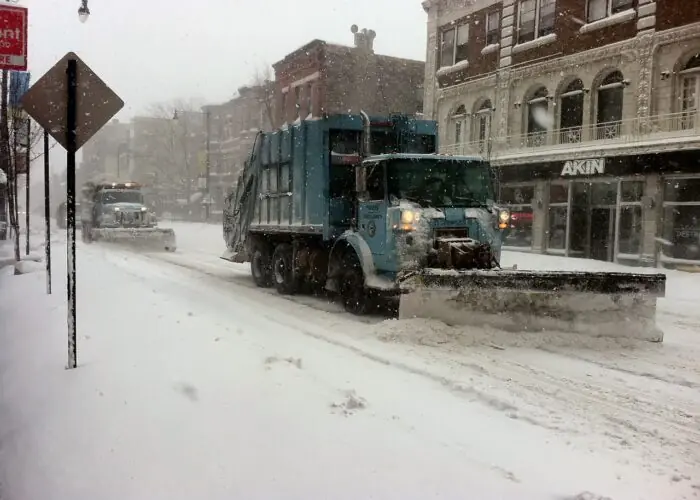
left=358, top=164, right=387, bottom=255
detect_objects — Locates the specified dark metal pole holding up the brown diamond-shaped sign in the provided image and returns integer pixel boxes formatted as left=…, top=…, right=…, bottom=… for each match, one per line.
left=66, top=59, right=78, bottom=369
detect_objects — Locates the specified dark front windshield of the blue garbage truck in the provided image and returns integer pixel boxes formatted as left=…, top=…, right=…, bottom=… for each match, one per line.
left=387, top=159, right=494, bottom=207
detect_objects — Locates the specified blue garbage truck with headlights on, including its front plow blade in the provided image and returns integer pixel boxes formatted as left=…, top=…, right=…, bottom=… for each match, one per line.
left=222, top=112, right=666, bottom=342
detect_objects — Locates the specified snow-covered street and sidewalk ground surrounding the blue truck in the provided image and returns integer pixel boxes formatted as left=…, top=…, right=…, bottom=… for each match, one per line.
left=0, top=224, right=700, bottom=500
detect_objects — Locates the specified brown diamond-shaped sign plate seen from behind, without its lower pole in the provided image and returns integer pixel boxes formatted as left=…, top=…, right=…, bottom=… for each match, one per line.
left=22, top=52, right=124, bottom=151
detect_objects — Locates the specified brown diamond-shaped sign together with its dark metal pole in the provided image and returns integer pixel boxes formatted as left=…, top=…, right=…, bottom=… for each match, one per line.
left=22, top=52, right=124, bottom=369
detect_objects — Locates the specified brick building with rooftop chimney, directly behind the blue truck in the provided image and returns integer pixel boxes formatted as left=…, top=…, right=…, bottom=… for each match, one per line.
left=273, top=25, right=425, bottom=126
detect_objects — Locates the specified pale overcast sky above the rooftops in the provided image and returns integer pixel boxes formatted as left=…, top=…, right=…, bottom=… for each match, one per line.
left=23, top=0, right=427, bottom=119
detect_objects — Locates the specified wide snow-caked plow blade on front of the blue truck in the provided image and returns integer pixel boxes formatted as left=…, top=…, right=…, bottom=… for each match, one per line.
left=399, top=269, right=666, bottom=342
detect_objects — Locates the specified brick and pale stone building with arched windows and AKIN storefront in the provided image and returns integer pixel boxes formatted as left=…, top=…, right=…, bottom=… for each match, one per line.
left=423, top=0, right=700, bottom=265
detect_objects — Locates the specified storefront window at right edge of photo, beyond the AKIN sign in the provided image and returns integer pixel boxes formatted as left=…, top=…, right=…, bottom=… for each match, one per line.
left=663, top=179, right=700, bottom=260
